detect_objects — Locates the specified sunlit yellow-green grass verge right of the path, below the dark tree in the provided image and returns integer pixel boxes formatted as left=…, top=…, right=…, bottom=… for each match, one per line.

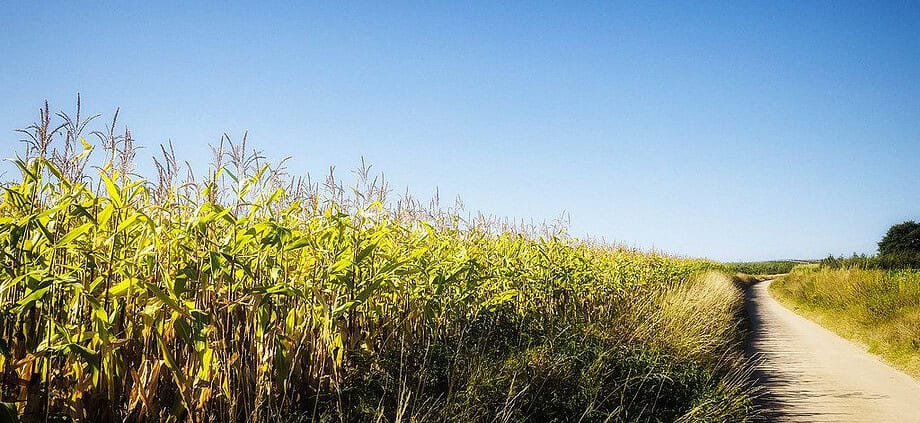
left=771, top=267, right=920, bottom=377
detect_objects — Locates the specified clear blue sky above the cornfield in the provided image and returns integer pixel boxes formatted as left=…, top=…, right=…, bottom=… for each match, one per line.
left=0, top=1, right=920, bottom=260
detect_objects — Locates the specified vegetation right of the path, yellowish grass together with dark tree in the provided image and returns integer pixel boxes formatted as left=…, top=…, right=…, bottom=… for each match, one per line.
left=770, top=222, right=920, bottom=377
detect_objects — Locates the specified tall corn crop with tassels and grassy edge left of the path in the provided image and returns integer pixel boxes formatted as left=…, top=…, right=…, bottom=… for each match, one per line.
left=0, top=101, right=750, bottom=421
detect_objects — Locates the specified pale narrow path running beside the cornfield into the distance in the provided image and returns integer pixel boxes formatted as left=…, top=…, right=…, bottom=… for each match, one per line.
left=746, top=281, right=920, bottom=422
